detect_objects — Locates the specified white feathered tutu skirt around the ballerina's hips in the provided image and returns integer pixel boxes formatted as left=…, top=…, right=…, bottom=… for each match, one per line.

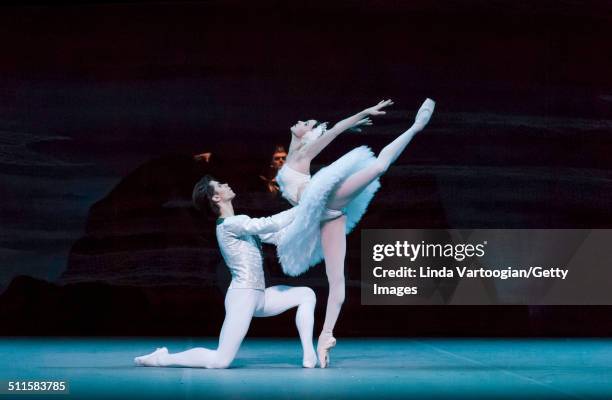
left=276, top=146, right=380, bottom=276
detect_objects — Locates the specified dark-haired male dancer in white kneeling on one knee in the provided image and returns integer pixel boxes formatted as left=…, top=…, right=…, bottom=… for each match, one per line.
left=134, top=176, right=317, bottom=368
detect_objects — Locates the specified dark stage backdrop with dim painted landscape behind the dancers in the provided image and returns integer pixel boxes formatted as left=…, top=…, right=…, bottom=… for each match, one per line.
left=0, top=0, right=612, bottom=335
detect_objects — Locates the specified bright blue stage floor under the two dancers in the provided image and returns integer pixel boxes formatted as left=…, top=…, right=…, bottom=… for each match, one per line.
left=0, top=338, right=612, bottom=399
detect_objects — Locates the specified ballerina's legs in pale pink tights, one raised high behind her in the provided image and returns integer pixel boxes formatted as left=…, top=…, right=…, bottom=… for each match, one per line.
left=319, top=99, right=435, bottom=340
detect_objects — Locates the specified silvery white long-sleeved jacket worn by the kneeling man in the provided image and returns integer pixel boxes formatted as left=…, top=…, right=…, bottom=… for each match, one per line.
left=217, top=207, right=296, bottom=290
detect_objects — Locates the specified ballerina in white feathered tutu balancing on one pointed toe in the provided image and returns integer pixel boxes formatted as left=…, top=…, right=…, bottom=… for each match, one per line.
left=276, top=99, right=435, bottom=368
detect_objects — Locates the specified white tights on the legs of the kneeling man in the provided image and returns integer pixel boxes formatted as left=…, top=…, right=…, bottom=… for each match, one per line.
left=137, top=286, right=316, bottom=368
